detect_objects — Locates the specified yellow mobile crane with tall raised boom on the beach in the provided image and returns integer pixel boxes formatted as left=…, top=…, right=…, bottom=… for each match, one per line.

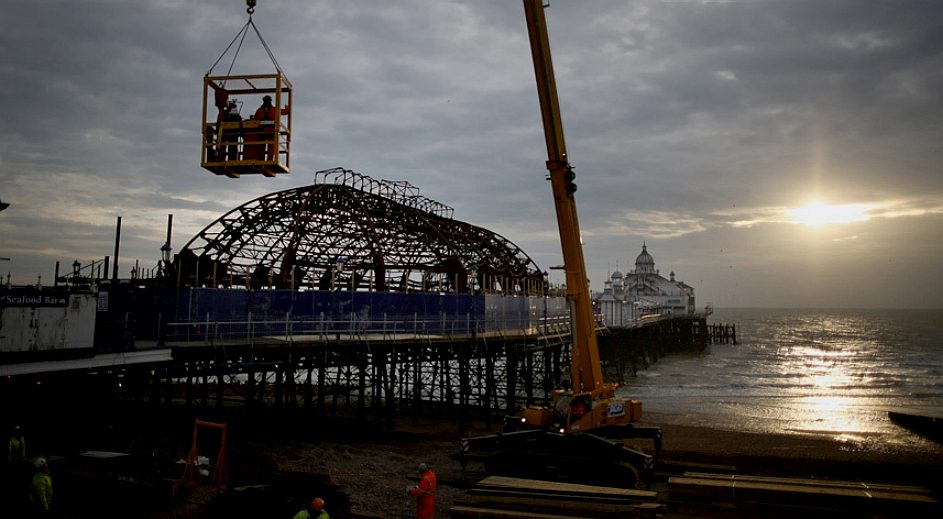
left=460, top=0, right=661, bottom=486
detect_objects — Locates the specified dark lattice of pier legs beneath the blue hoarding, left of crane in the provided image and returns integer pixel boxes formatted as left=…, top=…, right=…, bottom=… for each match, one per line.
left=138, top=335, right=570, bottom=429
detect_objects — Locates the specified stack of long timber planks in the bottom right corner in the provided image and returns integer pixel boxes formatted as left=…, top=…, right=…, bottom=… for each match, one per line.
left=668, top=472, right=943, bottom=518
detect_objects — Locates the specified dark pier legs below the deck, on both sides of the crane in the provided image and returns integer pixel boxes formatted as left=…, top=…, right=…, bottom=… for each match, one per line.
left=3, top=314, right=732, bottom=433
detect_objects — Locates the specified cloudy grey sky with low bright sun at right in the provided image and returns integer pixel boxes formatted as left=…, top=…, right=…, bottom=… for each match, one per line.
left=0, top=0, right=943, bottom=308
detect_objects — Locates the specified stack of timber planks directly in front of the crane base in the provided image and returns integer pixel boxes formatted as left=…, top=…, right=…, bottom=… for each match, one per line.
left=449, top=476, right=664, bottom=519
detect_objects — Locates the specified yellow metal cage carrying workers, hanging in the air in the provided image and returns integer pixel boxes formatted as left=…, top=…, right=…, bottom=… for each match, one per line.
left=200, top=71, right=293, bottom=178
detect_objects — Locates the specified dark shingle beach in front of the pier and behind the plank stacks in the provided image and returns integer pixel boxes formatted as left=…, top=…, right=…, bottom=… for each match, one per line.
left=5, top=398, right=943, bottom=519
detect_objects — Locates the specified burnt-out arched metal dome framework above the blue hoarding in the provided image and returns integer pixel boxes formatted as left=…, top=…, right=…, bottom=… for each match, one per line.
left=175, top=168, right=545, bottom=295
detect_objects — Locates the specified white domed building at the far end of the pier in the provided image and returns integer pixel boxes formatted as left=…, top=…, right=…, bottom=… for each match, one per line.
left=593, top=243, right=696, bottom=328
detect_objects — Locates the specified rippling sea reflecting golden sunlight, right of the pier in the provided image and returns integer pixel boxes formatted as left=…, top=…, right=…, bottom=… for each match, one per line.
left=619, top=308, right=943, bottom=452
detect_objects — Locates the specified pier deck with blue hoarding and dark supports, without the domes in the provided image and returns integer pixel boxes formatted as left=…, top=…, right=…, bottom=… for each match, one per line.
left=0, top=287, right=736, bottom=432
